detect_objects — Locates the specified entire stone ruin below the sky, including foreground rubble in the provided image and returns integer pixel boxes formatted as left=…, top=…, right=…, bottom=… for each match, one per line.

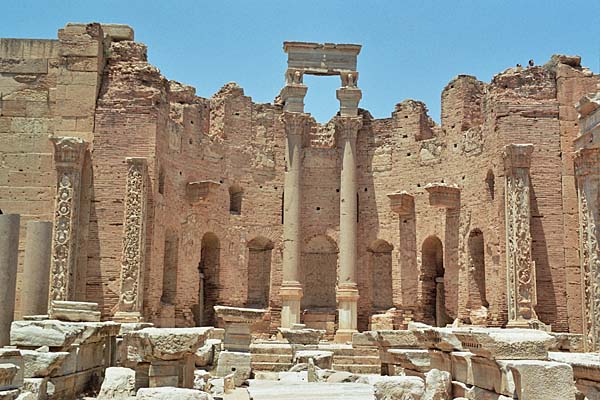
left=0, top=23, right=600, bottom=400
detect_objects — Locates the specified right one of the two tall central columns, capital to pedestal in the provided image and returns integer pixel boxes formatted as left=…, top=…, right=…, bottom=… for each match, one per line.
left=335, top=117, right=362, bottom=342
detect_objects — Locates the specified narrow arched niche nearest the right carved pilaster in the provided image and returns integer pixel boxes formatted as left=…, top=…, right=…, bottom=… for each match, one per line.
left=468, top=229, right=489, bottom=310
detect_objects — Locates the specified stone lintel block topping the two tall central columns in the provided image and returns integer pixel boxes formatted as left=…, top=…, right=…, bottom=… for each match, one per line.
left=283, top=42, right=361, bottom=75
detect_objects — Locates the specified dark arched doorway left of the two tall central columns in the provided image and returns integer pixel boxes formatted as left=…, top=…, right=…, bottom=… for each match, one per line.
left=195, top=232, right=221, bottom=326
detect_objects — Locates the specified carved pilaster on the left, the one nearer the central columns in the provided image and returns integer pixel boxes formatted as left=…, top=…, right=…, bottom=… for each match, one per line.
left=114, top=157, right=148, bottom=322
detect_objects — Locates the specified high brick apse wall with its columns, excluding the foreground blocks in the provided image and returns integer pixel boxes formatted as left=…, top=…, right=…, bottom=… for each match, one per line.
left=0, top=24, right=600, bottom=338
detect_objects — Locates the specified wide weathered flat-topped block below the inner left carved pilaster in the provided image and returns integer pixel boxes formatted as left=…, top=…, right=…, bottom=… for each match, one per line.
left=126, top=327, right=212, bottom=362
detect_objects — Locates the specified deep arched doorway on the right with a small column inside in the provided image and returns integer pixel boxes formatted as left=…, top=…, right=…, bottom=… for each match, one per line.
left=421, top=236, right=451, bottom=326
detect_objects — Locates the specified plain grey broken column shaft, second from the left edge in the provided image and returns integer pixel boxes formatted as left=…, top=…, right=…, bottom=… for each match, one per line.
left=21, top=221, right=52, bottom=315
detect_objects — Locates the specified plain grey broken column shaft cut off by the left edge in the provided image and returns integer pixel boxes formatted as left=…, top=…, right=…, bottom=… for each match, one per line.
left=0, top=214, right=21, bottom=347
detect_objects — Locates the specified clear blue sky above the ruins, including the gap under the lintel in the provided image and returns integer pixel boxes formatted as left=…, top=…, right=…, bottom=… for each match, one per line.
left=0, top=0, right=600, bottom=121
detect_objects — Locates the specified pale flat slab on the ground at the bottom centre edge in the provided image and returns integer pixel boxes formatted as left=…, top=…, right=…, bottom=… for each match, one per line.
left=248, top=380, right=375, bottom=400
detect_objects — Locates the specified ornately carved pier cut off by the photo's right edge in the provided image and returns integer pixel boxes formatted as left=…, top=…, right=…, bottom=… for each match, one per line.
left=574, top=93, right=600, bottom=351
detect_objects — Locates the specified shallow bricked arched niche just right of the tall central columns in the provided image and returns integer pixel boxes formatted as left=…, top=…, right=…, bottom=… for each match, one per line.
left=367, top=239, right=394, bottom=312
